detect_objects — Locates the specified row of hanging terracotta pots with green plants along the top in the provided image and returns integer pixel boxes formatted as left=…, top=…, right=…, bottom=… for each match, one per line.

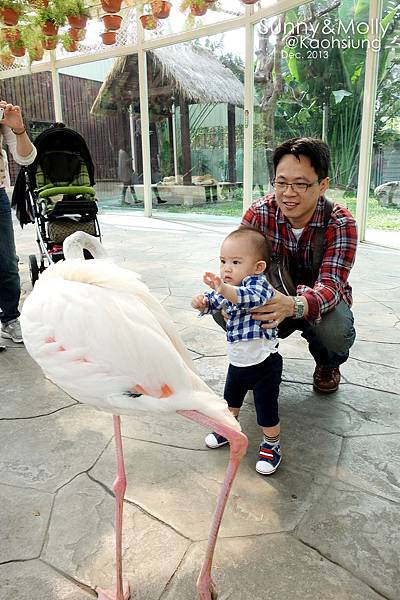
left=0, top=0, right=258, bottom=61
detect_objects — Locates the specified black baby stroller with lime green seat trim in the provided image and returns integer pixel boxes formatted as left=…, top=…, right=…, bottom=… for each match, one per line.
left=17, top=123, right=101, bottom=286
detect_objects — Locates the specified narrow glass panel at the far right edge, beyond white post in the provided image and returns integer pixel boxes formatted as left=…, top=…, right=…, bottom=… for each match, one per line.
left=365, top=0, right=400, bottom=248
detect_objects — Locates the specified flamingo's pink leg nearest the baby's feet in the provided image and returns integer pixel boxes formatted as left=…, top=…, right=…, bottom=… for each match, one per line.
left=177, top=410, right=248, bottom=600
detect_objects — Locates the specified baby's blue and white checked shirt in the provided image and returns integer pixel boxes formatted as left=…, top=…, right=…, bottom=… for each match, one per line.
left=200, top=274, right=278, bottom=342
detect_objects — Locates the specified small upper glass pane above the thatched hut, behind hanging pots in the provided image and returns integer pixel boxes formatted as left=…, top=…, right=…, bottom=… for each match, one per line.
left=141, top=0, right=244, bottom=39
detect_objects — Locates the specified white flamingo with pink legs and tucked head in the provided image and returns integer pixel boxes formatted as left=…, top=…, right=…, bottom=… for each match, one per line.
left=21, top=232, right=248, bottom=600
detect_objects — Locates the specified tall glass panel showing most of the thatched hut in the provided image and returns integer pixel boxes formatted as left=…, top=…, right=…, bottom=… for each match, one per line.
left=147, top=30, right=244, bottom=215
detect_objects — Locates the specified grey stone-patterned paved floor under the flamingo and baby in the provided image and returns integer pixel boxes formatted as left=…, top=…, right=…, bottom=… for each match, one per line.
left=0, top=213, right=400, bottom=600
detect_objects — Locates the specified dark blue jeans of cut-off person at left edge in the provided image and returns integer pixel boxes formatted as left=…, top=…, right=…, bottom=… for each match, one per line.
left=0, top=188, right=21, bottom=323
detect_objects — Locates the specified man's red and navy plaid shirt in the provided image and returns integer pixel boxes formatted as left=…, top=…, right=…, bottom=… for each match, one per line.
left=242, top=194, right=357, bottom=322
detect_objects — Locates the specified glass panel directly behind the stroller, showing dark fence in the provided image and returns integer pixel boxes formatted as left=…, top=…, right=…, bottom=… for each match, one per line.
left=60, top=56, right=143, bottom=210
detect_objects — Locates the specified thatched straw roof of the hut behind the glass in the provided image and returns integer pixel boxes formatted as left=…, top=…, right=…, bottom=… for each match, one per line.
left=91, top=44, right=244, bottom=115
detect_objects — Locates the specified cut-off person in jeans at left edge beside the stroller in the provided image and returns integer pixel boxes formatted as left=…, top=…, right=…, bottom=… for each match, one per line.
left=0, top=100, right=36, bottom=343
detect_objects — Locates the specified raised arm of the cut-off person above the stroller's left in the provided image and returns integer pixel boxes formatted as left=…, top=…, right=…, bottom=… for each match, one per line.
left=0, top=102, right=36, bottom=165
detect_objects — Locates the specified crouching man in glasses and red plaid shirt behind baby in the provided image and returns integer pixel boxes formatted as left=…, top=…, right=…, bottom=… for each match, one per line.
left=242, top=138, right=357, bottom=393
